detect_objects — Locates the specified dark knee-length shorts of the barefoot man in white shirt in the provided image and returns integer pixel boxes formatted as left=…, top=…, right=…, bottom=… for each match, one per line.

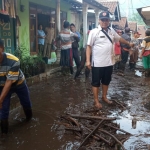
left=92, top=66, right=113, bottom=87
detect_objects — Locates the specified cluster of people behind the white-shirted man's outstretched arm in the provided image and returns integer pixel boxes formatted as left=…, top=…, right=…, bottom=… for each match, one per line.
left=114, top=27, right=141, bottom=76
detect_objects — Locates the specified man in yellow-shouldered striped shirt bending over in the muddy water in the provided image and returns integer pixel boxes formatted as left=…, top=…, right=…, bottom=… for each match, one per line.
left=0, top=39, right=32, bottom=135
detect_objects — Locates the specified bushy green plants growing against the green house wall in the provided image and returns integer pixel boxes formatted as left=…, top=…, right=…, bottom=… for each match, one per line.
left=14, top=46, right=45, bottom=77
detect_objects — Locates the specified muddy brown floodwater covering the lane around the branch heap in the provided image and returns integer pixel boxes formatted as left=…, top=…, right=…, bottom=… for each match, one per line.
left=0, top=63, right=150, bottom=150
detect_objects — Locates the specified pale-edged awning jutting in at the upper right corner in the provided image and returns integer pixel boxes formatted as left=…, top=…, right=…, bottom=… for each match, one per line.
left=137, top=6, right=150, bottom=25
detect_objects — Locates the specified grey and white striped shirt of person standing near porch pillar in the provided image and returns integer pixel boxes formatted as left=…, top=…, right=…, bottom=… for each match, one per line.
left=58, top=29, right=76, bottom=50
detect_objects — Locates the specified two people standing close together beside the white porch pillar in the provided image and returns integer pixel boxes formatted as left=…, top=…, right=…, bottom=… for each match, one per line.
left=56, top=21, right=80, bottom=74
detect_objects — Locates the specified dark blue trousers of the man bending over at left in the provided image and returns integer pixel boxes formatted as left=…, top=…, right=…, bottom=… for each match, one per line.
left=0, top=83, right=32, bottom=120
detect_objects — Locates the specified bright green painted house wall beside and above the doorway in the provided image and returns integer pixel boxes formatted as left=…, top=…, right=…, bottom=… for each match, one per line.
left=18, top=0, right=71, bottom=55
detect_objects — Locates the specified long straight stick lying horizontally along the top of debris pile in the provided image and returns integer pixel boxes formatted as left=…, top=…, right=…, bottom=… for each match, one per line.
left=69, top=114, right=117, bottom=120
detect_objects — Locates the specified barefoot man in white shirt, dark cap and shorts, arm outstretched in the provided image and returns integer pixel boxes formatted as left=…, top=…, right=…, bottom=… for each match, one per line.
left=86, top=11, right=134, bottom=109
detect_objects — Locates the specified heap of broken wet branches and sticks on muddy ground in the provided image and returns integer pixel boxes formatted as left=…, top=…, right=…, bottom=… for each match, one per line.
left=59, top=112, right=131, bottom=150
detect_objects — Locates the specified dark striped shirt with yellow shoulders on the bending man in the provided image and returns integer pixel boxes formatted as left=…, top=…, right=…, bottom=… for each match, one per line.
left=0, top=53, right=25, bottom=87
